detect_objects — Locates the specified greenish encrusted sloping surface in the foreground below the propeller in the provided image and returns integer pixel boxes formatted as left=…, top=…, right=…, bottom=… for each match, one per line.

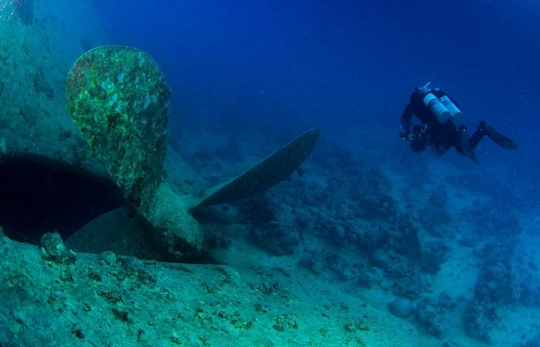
left=0, top=231, right=418, bottom=347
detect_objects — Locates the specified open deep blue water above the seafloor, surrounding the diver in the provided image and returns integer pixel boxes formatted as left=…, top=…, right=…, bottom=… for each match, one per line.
left=96, top=0, right=540, bottom=204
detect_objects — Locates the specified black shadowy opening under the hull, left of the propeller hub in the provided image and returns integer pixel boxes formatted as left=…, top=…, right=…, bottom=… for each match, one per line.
left=0, top=158, right=125, bottom=244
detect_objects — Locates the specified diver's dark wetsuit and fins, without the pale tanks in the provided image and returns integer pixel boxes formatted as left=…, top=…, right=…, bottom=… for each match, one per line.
left=401, top=88, right=517, bottom=164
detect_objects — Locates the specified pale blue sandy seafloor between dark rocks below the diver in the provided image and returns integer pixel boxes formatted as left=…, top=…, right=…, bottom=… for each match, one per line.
left=175, top=126, right=540, bottom=346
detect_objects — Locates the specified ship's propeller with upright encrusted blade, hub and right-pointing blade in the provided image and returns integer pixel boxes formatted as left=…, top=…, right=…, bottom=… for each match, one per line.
left=66, top=46, right=320, bottom=261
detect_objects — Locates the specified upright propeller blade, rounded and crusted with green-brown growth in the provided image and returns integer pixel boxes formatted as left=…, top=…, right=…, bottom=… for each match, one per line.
left=66, top=46, right=171, bottom=212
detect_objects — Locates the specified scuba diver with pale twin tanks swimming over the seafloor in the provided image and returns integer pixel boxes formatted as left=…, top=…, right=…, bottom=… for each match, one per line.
left=399, top=83, right=518, bottom=164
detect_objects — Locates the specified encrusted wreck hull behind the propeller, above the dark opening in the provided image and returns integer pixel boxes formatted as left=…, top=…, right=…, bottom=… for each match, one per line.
left=0, top=0, right=107, bottom=177
